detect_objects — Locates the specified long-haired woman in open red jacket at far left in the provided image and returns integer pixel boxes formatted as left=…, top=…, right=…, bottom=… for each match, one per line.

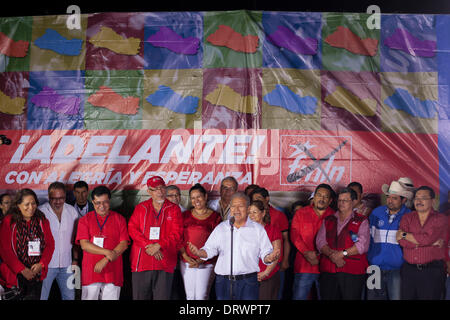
left=0, top=189, right=55, bottom=300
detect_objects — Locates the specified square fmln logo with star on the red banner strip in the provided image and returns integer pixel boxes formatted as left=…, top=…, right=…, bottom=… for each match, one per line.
left=280, top=135, right=352, bottom=186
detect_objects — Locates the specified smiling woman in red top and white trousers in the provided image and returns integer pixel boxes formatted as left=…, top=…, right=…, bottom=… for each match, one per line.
left=180, top=183, right=222, bottom=300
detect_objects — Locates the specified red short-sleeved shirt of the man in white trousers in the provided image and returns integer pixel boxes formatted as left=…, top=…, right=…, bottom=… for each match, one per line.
left=76, top=211, right=130, bottom=287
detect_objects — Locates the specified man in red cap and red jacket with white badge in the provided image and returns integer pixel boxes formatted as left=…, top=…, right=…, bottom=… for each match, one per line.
left=128, top=176, right=183, bottom=300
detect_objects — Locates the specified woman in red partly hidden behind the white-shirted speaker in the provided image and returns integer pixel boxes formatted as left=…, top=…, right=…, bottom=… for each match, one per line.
left=248, top=200, right=283, bottom=300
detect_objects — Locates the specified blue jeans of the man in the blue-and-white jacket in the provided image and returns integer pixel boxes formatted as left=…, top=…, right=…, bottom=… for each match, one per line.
left=367, top=269, right=401, bottom=300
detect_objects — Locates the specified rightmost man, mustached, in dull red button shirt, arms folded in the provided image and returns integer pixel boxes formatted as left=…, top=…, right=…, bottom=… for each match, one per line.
left=397, top=186, right=448, bottom=300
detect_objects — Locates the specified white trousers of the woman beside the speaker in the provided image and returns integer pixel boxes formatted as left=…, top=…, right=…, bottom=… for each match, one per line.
left=180, top=261, right=214, bottom=300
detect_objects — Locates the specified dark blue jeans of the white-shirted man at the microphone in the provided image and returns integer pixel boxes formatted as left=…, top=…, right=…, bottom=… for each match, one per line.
left=216, top=274, right=259, bottom=300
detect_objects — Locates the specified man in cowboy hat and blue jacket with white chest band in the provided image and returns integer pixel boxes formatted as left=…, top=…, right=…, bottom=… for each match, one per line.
left=367, top=181, right=413, bottom=300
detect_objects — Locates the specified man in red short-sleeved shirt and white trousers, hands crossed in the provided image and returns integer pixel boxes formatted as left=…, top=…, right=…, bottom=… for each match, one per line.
left=76, top=186, right=129, bottom=300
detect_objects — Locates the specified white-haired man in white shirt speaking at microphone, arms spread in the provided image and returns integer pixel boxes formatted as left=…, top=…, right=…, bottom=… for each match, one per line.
left=188, top=192, right=280, bottom=300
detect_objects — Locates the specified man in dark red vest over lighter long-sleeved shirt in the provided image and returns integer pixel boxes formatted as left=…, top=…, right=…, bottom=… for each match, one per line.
left=316, top=188, right=370, bottom=300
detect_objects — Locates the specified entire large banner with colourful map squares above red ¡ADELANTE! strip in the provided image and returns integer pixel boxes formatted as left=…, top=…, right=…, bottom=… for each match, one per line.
left=0, top=11, right=450, bottom=202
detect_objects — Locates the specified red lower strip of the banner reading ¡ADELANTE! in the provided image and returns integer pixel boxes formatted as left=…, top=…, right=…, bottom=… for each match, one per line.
left=0, top=129, right=439, bottom=193
